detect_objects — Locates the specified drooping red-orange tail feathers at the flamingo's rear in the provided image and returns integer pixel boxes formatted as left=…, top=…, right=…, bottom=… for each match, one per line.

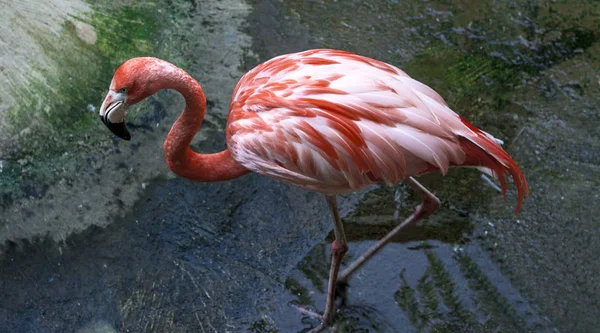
left=459, top=119, right=529, bottom=215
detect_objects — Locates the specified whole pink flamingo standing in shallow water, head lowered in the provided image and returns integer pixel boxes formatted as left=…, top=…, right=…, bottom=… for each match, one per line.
left=100, top=49, right=529, bottom=332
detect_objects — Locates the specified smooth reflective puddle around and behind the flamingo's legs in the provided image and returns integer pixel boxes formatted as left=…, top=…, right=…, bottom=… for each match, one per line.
left=276, top=184, right=542, bottom=332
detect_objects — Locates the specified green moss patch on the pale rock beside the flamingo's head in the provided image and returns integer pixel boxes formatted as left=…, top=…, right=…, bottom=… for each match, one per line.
left=0, top=2, right=165, bottom=207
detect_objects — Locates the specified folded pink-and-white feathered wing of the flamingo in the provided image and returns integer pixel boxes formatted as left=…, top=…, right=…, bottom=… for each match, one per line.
left=227, top=50, right=469, bottom=193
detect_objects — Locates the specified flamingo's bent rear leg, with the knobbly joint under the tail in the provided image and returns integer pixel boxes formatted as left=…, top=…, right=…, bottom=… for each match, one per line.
left=337, top=177, right=440, bottom=303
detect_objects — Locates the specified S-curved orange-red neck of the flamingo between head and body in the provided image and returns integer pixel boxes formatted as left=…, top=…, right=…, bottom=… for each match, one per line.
left=160, top=64, right=249, bottom=182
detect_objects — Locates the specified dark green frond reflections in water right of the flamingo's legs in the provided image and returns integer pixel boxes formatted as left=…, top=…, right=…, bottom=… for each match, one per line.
left=395, top=250, right=527, bottom=332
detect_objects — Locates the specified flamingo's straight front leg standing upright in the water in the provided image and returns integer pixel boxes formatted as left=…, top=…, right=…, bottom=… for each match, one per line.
left=309, top=195, right=348, bottom=333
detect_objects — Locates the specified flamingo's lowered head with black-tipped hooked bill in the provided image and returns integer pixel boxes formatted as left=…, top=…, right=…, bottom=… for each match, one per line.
left=100, top=57, right=166, bottom=140
